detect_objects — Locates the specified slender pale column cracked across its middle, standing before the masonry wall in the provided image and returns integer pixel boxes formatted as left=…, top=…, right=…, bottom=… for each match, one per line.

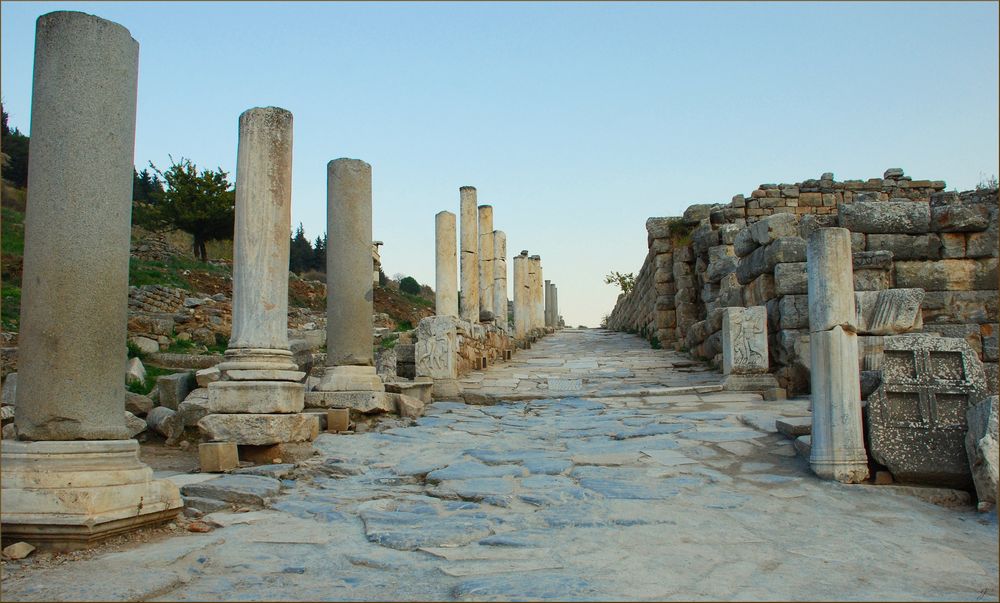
left=806, top=228, right=868, bottom=483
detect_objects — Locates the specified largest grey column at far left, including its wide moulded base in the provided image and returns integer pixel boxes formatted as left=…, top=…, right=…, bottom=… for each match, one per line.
left=0, top=11, right=180, bottom=550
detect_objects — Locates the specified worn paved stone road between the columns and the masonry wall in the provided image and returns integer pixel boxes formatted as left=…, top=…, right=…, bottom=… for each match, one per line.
left=3, top=330, right=998, bottom=601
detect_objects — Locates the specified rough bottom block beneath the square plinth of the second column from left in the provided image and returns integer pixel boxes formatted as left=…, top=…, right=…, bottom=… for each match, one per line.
left=198, top=414, right=319, bottom=446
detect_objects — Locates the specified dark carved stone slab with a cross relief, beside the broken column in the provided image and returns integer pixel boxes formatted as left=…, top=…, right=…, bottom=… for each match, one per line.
left=868, top=335, right=986, bottom=488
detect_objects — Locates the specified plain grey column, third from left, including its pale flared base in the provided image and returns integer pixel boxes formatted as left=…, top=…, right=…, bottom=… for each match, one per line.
left=316, top=159, right=385, bottom=392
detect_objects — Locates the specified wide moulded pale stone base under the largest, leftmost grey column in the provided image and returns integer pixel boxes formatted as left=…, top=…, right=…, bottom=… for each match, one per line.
left=0, top=440, right=183, bottom=551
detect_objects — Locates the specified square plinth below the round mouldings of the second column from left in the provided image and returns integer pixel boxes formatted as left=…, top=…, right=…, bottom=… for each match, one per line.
left=208, top=381, right=305, bottom=414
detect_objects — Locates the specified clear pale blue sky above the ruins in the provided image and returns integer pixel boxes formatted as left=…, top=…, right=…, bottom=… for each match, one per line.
left=0, top=2, right=1000, bottom=326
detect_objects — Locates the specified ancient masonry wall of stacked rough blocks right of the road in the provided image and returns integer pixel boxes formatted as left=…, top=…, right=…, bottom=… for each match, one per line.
left=607, top=169, right=1000, bottom=394
